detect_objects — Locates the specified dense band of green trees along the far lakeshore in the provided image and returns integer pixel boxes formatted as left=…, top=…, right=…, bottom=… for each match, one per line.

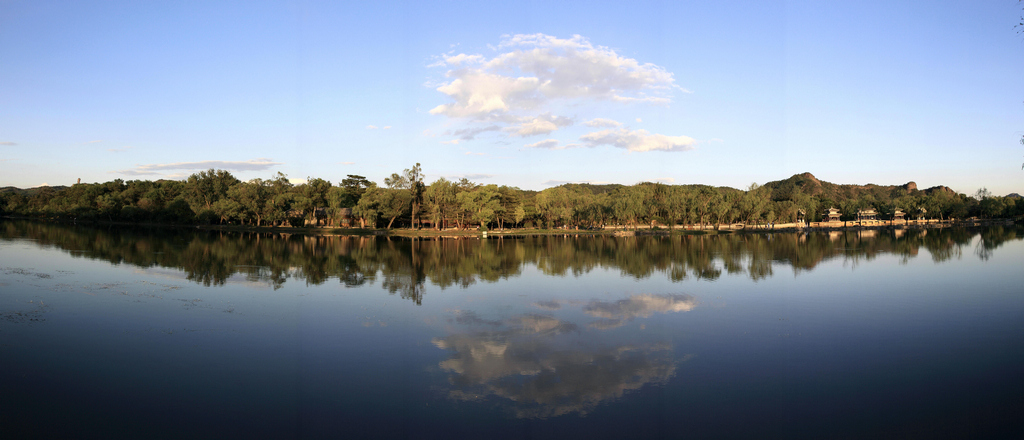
left=0, top=164, right=1024, bottom=229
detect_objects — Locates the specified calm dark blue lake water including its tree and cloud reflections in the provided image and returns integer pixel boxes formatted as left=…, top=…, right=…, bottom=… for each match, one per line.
left=0, top=221, right=1024, bottom=438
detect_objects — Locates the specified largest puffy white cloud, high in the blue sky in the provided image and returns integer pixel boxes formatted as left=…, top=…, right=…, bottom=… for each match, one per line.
left=430, top=34, right=679, bottom=144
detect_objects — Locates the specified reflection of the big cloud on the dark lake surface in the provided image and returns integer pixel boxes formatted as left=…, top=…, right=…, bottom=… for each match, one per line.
left=433, top=294, right=696, bottom=417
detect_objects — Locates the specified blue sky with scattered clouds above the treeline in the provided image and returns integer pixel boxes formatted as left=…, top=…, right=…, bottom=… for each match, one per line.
left=6, top=0, right=1024, bottom=195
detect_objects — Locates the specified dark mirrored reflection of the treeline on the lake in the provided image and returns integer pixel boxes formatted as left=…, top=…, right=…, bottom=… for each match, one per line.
left=0, top=221, right=1022, bottom=304
